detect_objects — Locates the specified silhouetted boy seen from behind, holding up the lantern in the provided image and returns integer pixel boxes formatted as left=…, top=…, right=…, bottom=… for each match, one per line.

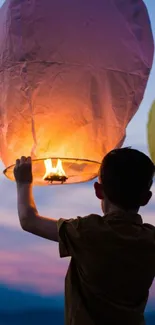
left=14, top=148, right=155, bottom=325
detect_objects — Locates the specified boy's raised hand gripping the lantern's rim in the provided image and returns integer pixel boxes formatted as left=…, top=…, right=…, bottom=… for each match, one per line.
left=14, top=157, right=33, bottom=184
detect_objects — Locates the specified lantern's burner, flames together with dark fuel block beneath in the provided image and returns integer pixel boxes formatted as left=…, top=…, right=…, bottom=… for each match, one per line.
left=43, top=159, right=67, bottom=183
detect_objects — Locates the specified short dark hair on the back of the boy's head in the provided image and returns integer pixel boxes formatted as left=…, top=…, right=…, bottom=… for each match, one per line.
left=100, top=147, right=155, bottom=209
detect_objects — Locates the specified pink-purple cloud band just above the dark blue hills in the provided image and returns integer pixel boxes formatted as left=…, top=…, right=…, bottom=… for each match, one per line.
left=0, top=251, right=67, bottom=294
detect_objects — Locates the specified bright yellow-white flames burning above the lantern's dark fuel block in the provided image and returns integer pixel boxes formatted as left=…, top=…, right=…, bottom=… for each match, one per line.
left=43, top=159, right=66, bottom=180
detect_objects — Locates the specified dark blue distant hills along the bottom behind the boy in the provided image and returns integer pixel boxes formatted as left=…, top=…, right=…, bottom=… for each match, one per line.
left=0, top=285, right=155, bottom=325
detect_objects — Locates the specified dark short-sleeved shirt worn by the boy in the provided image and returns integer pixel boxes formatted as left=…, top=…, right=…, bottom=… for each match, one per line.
left=58, top=213, right=155, bottom=325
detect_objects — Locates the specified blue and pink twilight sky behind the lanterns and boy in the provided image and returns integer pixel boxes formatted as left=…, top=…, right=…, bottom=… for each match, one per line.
left=0, top=0, right=155, bottom=316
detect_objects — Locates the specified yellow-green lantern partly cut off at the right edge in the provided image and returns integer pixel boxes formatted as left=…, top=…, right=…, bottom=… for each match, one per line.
left=147, top=101, right=155, bottom=164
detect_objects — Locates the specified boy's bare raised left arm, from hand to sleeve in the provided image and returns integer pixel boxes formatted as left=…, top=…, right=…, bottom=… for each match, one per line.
left=14, top=157, right=58, bottom=242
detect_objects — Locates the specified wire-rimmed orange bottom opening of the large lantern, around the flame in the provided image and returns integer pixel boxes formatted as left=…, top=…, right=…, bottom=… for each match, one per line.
left=3, top=157, right=101, bottom=186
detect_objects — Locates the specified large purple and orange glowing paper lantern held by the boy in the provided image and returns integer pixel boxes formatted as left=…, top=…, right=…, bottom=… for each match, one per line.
left=0, top=0, right=154, bottom=185
